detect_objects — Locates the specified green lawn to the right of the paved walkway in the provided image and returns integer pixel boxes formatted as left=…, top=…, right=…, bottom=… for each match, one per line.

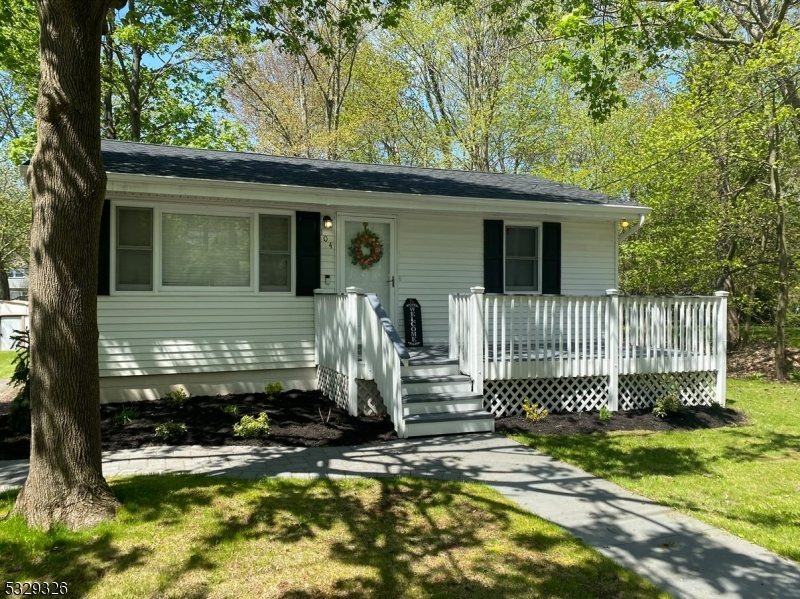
left=514, top=379, right=800, bottom=561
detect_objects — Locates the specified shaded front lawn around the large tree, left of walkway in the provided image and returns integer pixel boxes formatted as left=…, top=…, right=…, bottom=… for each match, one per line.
left=0, top=475, right=667, bottom=599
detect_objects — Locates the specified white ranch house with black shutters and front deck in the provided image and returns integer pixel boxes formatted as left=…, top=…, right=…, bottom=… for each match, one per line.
left=72, top=141, right=726, bottom=436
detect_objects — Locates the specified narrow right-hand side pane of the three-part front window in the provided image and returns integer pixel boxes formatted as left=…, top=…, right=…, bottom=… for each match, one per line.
left=258, top=214, right=292, bottom=291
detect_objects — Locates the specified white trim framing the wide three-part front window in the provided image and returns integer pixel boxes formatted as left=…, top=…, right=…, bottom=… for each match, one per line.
left=110, top=200, right=297, bottom=297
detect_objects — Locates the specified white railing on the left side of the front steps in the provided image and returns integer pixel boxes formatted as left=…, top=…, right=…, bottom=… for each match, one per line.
left=314, top=287, right=409, bottom=437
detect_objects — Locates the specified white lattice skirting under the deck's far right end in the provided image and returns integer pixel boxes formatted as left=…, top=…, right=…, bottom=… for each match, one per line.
left=619, top=372, right=717, bottom=410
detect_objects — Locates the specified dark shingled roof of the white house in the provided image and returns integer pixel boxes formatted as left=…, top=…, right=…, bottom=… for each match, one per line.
left=102, top=140, right=640, bottom=206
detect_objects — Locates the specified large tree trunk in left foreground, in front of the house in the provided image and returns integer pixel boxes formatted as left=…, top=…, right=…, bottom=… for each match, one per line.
left=15, top=0, right=119, bottom=529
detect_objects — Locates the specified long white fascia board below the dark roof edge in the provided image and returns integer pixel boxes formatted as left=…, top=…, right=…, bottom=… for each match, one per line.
left=107, top=173, right=651, bottom=221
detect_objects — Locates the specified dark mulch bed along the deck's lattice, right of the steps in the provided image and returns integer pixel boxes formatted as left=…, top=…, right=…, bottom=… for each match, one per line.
left=495, top=406, right=747, bottom=435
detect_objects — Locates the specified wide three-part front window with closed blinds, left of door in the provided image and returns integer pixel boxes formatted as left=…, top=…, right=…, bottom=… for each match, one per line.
left=115, top=206, right=292, bottom=292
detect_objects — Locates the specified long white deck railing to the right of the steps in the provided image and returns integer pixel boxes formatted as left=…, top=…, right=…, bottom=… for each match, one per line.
left=450, top=288, right=727, bottom=406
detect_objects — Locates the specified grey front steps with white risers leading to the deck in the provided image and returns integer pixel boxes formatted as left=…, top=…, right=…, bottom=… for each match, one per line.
left=401, top=358, right=494, bottom=437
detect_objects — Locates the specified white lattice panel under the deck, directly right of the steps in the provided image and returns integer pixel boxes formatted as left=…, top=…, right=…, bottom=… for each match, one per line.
left=483, top=376, right=608, bottom=417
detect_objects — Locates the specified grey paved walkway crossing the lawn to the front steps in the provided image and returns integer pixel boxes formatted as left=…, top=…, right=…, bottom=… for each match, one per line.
left=0, top=434, right=800, bottom=599
